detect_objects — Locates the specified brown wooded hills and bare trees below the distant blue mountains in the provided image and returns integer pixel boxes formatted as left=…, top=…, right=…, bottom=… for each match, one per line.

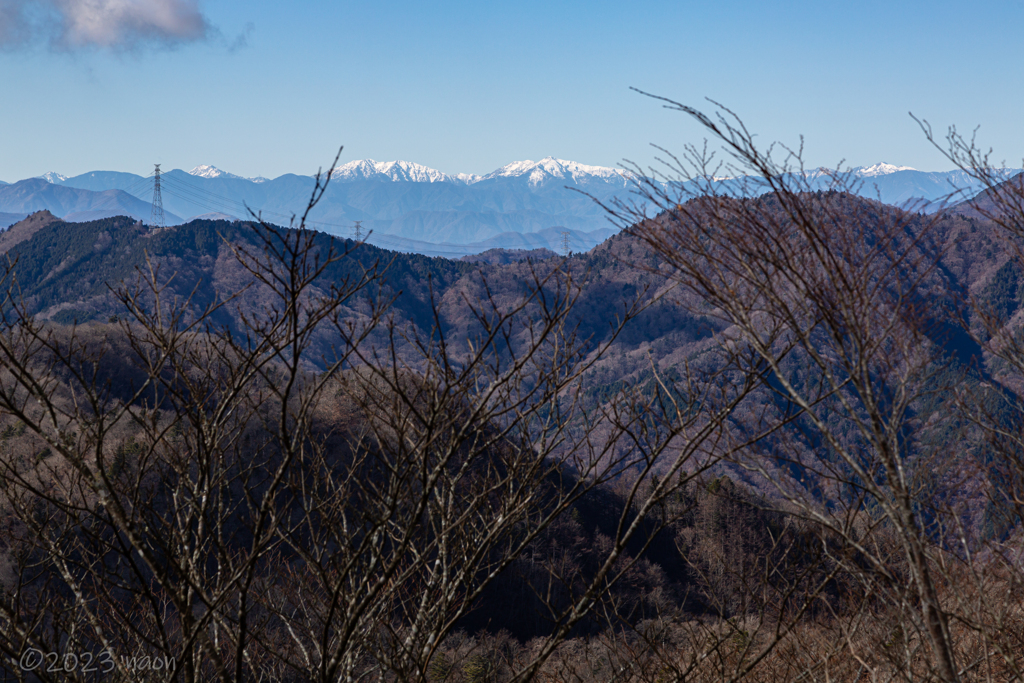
left=0, top=113, right=1024, bottom=682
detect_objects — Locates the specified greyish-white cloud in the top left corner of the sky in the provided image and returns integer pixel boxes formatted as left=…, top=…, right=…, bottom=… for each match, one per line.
left=0, top=0, right=216, bottom=50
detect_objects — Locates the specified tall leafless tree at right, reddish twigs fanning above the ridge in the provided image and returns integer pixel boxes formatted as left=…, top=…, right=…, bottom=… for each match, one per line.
left=616, top=94, right=969, bottom=681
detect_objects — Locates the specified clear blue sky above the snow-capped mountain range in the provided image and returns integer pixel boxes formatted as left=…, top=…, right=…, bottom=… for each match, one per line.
left=0, top=0, right=1024, bottom=181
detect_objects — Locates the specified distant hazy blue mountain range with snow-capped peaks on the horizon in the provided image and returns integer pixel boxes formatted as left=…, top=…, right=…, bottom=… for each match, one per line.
left=0, top=157, right=1018, bottom=257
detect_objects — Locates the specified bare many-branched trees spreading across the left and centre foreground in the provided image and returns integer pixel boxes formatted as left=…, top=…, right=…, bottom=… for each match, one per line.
left=0, top=156, right=770, bottom=681
